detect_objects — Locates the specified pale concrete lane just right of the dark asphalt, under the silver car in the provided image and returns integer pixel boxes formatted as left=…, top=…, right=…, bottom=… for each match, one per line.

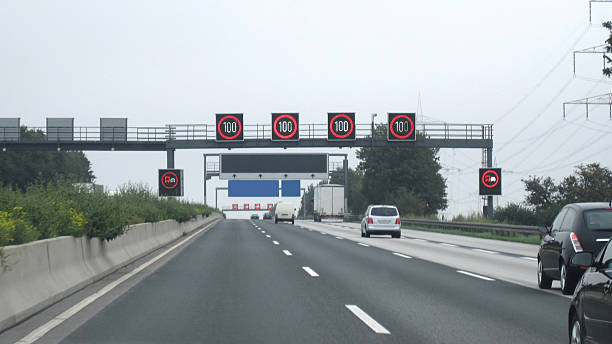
left=300, top=222, right=548, bottom=290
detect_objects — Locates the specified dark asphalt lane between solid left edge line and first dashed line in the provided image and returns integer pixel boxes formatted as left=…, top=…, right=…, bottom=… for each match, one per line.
left=63, top=220, right=371, bottom=343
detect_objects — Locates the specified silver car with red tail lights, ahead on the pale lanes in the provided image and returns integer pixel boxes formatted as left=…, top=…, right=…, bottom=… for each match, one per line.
left=361, top=205, right=402, bottom=238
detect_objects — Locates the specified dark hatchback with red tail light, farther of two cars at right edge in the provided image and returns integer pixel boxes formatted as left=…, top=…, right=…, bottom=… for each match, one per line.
left=538, top=202, right=612, bottom=295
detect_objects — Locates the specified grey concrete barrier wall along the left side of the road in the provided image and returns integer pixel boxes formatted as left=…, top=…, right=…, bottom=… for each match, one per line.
left=0, top=214, right=222, bottom=331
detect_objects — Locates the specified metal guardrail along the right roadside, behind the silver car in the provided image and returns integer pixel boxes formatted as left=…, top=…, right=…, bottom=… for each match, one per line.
left=344, top=215, right=539, bottom=236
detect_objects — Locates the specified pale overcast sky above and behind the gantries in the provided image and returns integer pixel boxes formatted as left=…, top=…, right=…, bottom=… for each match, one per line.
left=0, top=0, right=612, bottom=216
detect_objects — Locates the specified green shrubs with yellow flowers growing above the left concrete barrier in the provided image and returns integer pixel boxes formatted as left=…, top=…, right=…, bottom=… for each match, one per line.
left=0, top=180, right=212, bottom=247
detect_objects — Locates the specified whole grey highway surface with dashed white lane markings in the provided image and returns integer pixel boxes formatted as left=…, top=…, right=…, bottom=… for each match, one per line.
left=7, top=220, right=569, bottom=343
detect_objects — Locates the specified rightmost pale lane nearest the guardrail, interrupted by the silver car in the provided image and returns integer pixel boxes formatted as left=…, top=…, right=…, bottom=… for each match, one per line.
left=314, top=221, right=539, bottom=257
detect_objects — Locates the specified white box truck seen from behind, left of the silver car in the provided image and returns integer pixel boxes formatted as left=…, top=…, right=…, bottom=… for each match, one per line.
left=314, top=184, right=344, bottom=222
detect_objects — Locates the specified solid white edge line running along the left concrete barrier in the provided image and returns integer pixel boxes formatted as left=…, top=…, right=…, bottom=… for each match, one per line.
left=16, top=223, right=215, bottom=344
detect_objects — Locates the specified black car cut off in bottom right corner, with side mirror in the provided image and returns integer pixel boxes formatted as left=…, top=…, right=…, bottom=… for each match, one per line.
left=568, top=241, right=612, bottom=343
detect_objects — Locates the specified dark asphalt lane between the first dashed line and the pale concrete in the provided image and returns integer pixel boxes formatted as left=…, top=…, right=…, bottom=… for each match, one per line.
left=262, top=222, right=569, bottom=343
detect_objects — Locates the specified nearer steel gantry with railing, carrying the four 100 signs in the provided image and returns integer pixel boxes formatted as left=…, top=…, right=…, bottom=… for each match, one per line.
left=0, top=120, right=493, bottom=216
